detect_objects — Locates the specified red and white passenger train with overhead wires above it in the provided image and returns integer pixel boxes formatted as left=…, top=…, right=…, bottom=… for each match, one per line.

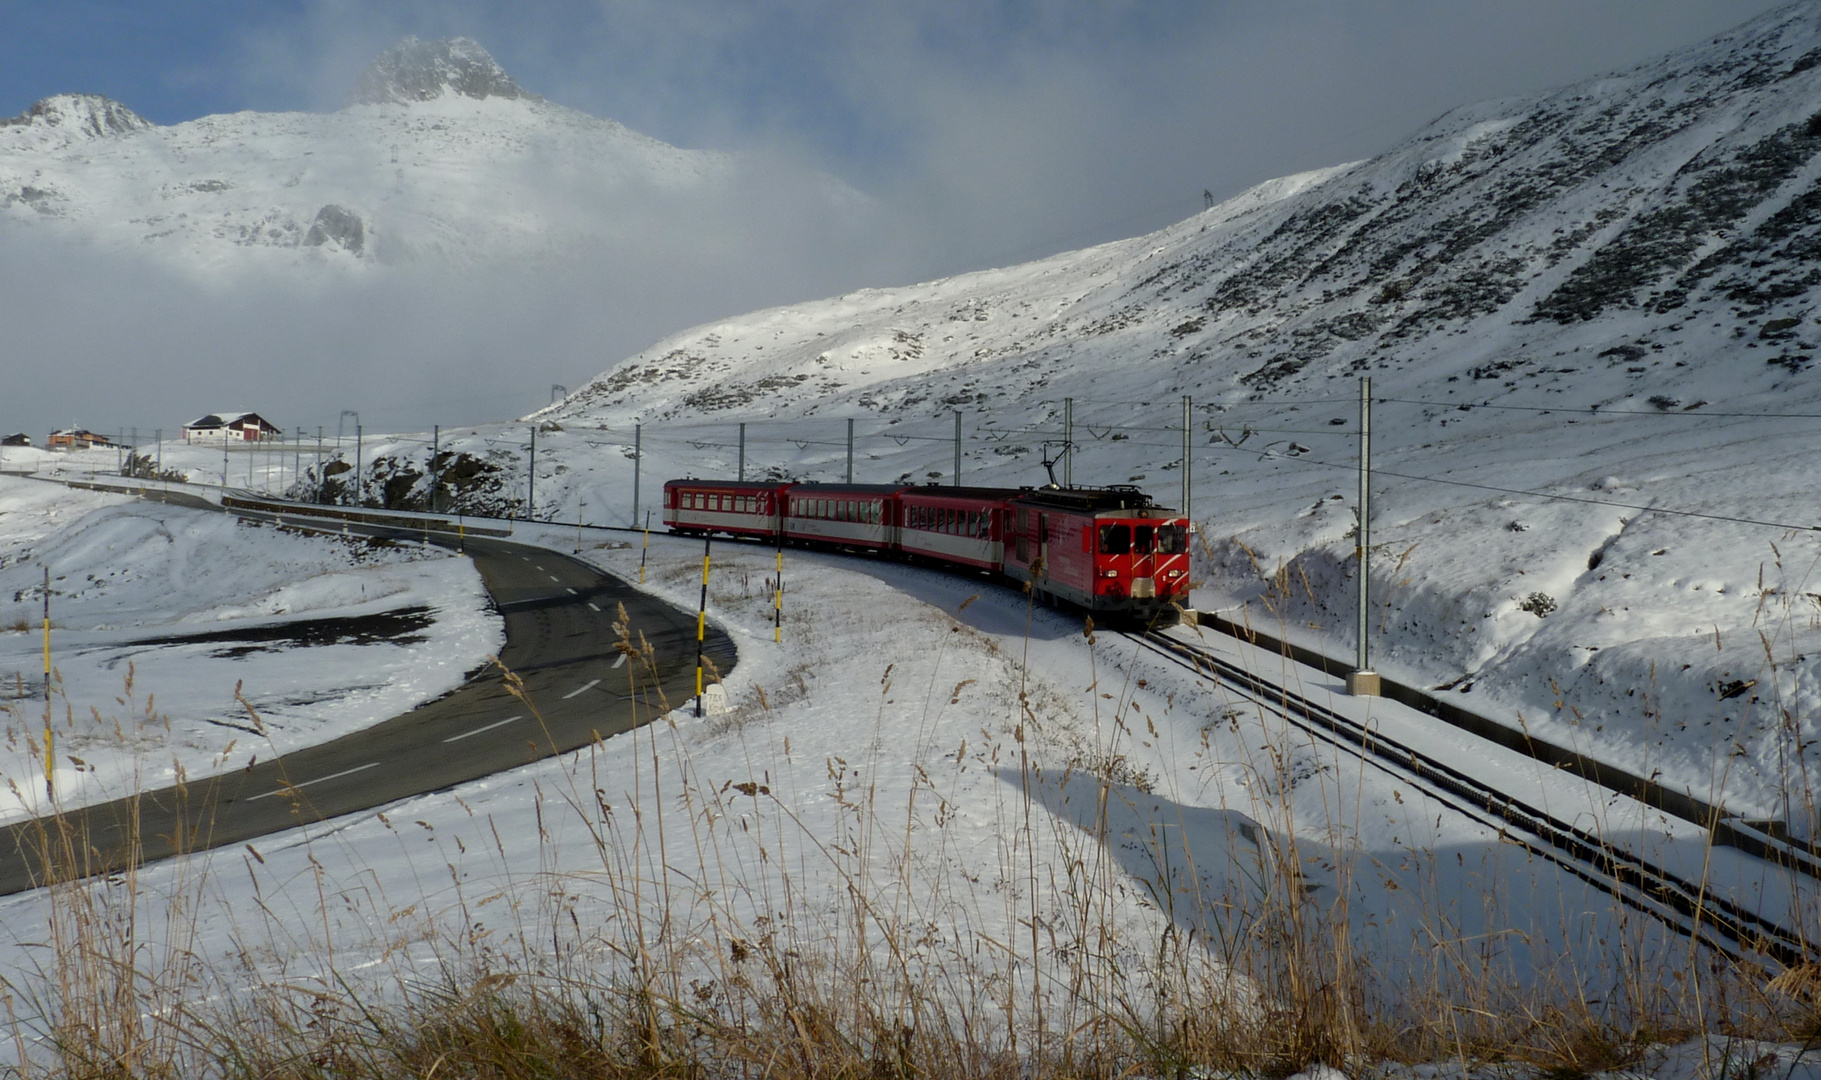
left=665, top=479, right=1189, bottom=621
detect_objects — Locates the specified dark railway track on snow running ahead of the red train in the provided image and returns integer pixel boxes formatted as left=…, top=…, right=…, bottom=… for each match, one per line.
left=1124, top=630, right=1821, bottom=967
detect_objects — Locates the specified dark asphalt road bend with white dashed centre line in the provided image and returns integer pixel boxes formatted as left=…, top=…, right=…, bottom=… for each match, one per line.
left=0, top=513, right=736, bottom=894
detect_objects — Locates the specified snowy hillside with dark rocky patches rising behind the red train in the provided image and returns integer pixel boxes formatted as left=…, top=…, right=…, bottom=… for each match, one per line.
left=537, top=0, right=1821, bottom=816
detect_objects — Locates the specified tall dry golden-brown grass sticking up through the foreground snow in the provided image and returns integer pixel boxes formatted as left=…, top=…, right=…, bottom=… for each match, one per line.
left=0, top=576, right=1821, bottom=1080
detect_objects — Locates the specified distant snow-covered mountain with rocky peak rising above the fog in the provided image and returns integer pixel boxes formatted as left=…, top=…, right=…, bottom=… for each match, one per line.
left=0, top=38, right=858, bottom=277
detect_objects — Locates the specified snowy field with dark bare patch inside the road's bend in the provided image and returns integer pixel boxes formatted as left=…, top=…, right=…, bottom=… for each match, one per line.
left=0, top=477, right=504, bottom=821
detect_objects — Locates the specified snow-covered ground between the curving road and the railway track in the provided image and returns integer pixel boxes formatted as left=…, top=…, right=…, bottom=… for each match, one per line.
left=0, top=509, right=1806, bottom=1063
